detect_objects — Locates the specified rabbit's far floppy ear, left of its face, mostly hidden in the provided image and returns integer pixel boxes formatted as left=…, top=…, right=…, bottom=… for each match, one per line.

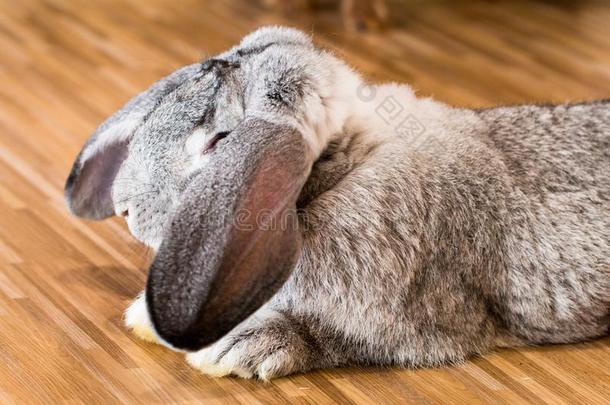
left=64, top=64, right=200, bottom=219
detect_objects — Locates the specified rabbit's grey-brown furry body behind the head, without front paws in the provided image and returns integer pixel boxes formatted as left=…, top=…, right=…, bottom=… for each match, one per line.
left=276, top=98, right=610, bottom=365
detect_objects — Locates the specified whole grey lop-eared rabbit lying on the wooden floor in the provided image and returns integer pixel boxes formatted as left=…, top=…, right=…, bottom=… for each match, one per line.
left=65, top=27, right=610, bottom=380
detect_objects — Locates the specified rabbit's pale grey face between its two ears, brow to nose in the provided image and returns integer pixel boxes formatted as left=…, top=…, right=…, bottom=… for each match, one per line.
left=112, top=66, right=244, bottom=249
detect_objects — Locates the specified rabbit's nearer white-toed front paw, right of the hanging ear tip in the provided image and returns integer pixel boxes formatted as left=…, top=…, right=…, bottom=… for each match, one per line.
left=186, top=310, right=312, bottom=380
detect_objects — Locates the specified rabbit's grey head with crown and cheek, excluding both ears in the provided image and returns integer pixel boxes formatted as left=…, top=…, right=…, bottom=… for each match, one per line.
left=102, top=26, right=358, bottom=249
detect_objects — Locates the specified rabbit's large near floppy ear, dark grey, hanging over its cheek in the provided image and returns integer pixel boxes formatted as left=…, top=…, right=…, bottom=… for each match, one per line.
left=146, top=118, right=311, bottom=350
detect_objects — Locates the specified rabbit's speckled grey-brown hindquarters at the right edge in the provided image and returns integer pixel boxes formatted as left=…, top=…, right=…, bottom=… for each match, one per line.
left=480, top=101, right=610, bottom=343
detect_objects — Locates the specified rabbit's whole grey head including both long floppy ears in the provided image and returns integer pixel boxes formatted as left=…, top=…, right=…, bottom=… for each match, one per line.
left=66, top=27, right=359, bottom=350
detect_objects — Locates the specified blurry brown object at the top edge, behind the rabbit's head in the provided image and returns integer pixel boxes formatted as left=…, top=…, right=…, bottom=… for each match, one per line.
left=263, top=0, right=389, bottom=31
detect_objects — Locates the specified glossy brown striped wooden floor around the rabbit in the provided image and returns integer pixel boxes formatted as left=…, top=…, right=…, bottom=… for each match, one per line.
left=0, top=0, right=610, bottom=404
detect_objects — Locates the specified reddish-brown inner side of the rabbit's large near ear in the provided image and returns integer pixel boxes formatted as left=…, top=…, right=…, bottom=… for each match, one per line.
left=204, top=155, right=304, bottom=316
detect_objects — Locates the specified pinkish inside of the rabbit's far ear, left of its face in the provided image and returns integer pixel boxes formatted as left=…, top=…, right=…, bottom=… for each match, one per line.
left=66, top=141, right=129, bottom=219
